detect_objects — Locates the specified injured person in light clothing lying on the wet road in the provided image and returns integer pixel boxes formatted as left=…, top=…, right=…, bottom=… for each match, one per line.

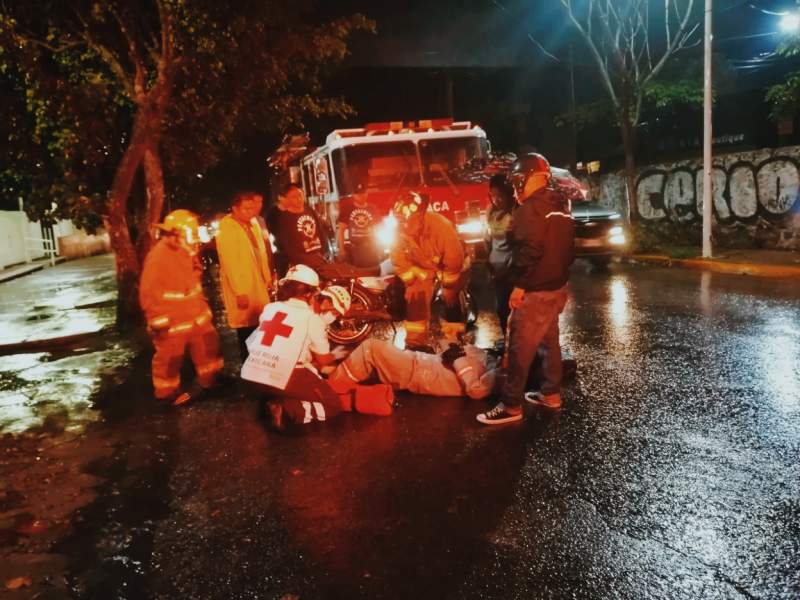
left=328, top=338, right=496, bottom=400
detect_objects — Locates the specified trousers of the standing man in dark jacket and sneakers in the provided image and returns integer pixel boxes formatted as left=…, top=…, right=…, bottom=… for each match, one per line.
left=501, top=286, right=567, bottom=407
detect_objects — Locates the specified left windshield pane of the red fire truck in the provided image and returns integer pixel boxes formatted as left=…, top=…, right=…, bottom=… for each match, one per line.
left=332, top=141, right=420, bottom=196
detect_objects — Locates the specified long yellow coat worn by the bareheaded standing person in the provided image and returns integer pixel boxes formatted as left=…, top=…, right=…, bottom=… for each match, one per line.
left=217, top=215, right=272, bottom=329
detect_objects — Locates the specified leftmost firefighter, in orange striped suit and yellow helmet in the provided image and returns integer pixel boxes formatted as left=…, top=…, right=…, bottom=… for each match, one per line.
left=139, top=209, right=222, bottom=400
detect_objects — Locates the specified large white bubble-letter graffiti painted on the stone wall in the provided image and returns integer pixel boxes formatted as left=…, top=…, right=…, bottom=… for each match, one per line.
left=636, top=155, right=800, bottom=223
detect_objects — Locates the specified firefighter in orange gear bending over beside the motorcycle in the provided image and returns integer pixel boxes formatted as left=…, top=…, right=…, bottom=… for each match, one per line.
left=391, top=192, right=469, bottom=350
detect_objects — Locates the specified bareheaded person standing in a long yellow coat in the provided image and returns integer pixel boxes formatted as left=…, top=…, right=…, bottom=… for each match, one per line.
left=217, top=191, right=273, bottom=361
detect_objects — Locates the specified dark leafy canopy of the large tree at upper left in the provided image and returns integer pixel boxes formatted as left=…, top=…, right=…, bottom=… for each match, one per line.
left=0, top=0, right=373, bottom=226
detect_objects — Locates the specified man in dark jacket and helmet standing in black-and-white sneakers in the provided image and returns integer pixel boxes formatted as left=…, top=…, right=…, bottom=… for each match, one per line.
left=478, top=154, right=575, bottom=425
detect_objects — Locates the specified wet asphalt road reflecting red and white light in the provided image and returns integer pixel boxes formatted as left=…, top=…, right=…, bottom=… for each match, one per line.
left=1, top=264, right=800, bottom=598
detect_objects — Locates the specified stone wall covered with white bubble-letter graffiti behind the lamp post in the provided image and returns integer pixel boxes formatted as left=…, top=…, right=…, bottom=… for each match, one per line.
left=591, top=146, right=800, bottom=249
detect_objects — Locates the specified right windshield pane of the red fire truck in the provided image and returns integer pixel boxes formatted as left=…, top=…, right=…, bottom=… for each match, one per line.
left=419, top=137, right=488, bottom=185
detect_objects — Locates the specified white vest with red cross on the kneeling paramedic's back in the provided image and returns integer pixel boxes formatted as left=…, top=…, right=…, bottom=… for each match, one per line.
left=242, top=302, right=314, bottom=390
